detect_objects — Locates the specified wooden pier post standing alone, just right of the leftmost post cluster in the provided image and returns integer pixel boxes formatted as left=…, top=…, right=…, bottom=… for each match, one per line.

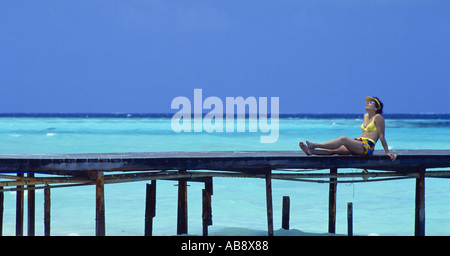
left=95, top=171, right=105, bottom=236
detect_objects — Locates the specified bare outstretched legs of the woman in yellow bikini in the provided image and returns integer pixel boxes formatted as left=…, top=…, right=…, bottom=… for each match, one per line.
left=299, top=137, right=364, bottom=155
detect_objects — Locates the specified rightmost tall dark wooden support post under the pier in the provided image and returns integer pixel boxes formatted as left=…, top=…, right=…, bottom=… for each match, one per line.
left=414, top=167, right=425, bottom=236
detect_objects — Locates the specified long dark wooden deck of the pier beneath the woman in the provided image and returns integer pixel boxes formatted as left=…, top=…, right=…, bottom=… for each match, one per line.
left=0, top=150, right=450, bottom=173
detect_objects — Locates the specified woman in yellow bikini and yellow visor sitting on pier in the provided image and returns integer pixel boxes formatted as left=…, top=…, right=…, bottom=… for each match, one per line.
left=299, top=97, right=397, bottom=160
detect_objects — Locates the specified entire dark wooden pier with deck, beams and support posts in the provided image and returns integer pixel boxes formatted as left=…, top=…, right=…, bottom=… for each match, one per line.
left=0, top=150, right=450, bottom=236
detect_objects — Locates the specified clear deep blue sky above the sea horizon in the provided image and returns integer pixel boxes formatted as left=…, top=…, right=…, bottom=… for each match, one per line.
left=0, top=0, right=450, bottom=113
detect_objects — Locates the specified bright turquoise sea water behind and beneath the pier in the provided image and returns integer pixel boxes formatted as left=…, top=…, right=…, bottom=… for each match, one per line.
left=0, top=114, right=450, bottom=235
